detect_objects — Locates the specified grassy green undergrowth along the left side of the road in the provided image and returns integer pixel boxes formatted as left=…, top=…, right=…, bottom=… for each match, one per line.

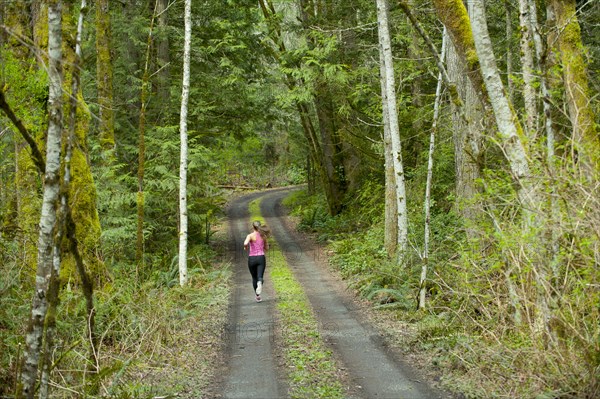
left=0, top=237, right=231, bottom=399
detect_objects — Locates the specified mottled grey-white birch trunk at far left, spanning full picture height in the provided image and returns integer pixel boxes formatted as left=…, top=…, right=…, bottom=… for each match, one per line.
left=17, top=0, right=63, bottom=399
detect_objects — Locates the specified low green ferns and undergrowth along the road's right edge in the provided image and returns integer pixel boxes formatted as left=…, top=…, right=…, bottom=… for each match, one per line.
left=284, top=187, right=600, bottom=399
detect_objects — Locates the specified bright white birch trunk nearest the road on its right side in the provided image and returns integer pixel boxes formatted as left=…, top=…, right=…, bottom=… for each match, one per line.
left=377, top=0, right=408, bottom=264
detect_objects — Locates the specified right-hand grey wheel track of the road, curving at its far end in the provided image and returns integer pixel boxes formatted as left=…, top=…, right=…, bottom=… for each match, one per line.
left=261, top=191, right=445, bottom=399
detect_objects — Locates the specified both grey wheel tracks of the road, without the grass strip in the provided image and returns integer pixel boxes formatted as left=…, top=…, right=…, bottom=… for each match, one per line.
left=216, top=190, right=444, bottom=399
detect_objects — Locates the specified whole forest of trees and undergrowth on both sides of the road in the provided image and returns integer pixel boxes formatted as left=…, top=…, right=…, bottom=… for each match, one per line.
left=0, top=0, right=600, bottom=399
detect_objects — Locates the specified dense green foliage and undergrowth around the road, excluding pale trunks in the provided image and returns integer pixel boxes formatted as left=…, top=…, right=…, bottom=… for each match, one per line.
left=0, top=0, right=600, bottom=398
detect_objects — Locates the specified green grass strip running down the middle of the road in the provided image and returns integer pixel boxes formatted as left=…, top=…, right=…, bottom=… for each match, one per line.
left=249, top=199, right=344, bottom=399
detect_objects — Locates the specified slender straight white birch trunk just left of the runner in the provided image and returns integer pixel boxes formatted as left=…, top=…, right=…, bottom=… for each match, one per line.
left=179, top=0, right=191, bottom=287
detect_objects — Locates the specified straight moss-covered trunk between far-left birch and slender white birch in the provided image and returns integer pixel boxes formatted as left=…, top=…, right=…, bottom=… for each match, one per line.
left=96, top=0, right=115, bottom=156
